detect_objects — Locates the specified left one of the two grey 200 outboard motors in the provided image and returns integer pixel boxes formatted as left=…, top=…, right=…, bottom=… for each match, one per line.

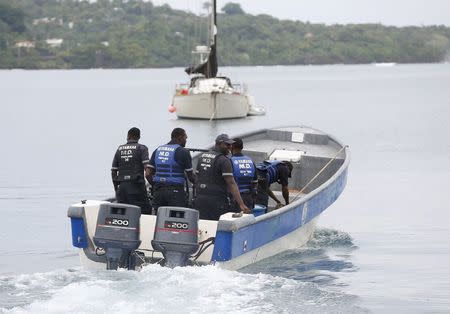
left=94, top=203, right=141, bottom=270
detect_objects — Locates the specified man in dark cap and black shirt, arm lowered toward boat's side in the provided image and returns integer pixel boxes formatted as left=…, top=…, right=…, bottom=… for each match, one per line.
left=194, top=134, right=251, bottom=220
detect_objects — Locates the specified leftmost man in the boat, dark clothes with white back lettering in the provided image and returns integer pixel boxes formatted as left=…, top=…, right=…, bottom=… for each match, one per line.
left=111, top=128, right=151, bottom=214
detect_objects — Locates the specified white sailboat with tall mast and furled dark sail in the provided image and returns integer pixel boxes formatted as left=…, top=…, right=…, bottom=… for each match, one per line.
left=169, top=0, right=265, bottom=120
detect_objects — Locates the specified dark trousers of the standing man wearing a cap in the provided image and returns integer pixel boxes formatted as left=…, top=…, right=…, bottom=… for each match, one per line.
left=194, top=194, right=236, bottom=220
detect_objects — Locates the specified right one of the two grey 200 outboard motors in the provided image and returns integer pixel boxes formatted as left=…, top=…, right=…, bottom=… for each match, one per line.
left=152, top=207, right=199, bottom=268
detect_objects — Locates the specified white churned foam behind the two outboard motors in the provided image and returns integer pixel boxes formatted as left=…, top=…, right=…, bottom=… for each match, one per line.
left=0, top=265, right=358, bottom=313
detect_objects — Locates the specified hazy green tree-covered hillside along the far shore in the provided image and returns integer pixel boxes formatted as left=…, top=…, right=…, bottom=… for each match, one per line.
left=0, top=0, right=450, bottom=69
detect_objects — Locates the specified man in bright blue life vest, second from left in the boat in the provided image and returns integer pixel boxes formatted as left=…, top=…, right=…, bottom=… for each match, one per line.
left=150, top=128, right=195, bottom=211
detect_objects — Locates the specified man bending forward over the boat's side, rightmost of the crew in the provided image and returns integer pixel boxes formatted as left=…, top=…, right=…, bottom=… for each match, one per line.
left=256, top=160, right=293, bottom=209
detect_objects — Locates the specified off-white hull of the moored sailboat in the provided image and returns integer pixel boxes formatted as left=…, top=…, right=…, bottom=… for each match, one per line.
left=173, top=93, right=250, bottom=120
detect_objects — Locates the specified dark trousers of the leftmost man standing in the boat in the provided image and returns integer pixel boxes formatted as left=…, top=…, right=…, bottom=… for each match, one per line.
left=117, top=181, right=152, bottom=215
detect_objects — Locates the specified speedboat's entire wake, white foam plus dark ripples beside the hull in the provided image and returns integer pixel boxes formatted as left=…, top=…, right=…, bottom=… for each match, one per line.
left=0, top=229, right=362, bottom=313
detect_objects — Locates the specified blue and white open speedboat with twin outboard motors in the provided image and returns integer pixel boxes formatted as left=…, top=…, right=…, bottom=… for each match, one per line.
left=68, top=126, right=349, bottom=270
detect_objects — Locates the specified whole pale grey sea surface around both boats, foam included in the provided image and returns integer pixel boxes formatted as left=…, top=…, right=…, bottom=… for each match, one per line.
left=0, top=64, right=450, bottom=313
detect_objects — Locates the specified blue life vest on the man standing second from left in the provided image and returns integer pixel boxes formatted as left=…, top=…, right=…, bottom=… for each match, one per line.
left=153, top=144, right=185, bottom=185
